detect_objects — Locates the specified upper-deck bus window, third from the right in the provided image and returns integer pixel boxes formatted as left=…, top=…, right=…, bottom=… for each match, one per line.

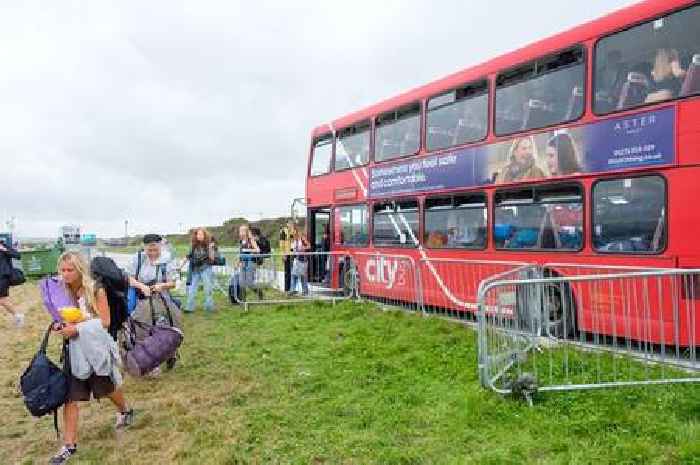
left=427, top=81, right=489, bottom=150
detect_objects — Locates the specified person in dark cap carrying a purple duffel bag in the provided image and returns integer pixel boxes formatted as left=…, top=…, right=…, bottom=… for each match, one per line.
left=129, top=234, right=182, bottom=376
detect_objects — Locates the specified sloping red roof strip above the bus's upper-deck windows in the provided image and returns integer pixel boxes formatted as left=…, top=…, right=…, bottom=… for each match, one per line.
left=311, top=0, right=696, bottom=137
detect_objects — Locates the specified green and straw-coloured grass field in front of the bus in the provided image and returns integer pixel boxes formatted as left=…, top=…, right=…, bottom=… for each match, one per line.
left=0, top=286, right=700, bottom=465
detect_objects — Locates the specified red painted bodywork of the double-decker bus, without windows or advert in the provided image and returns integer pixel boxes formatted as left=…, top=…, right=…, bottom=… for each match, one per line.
left=306, top=0, right=700, bottom=344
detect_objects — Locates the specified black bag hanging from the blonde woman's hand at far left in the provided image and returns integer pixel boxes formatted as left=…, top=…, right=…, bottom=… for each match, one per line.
left=19, top=326, right=68, bottom=433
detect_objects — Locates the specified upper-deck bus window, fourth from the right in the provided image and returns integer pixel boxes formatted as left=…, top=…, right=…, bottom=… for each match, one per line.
left=374, top=103, right=420, bottom=161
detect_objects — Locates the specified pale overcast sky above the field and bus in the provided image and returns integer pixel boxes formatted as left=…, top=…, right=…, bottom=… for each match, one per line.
left=0, top=0, right=633, bottom=237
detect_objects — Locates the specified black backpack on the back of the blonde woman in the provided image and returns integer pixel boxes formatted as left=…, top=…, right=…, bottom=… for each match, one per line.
left=90, top=257, right=129, bottom=341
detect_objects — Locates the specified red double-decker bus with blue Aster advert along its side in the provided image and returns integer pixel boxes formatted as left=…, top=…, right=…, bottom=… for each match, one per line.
left=306, top=0, right=700, bottom=342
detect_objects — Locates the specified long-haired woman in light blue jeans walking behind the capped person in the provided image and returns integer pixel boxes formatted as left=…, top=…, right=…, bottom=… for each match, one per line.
left=185, top=228, right=215, bottom=313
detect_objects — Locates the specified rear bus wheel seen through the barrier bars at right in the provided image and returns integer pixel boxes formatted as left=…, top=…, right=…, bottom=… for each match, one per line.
left=542, top=284, right=576, bottom=339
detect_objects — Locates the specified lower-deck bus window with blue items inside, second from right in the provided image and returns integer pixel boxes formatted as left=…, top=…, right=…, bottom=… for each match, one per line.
left=494, top=185, right=583, bottom=250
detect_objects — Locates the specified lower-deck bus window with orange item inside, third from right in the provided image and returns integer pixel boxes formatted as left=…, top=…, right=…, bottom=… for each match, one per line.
left=425, top=193, right=486, bottom=249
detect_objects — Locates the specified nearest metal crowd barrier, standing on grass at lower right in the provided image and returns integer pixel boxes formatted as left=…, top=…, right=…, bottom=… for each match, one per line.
left=478, top=267, right=700, bottom=398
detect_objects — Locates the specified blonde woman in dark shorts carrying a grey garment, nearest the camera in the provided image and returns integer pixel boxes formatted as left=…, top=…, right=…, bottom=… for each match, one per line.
left=49, top=252, right=134, bottom=465
